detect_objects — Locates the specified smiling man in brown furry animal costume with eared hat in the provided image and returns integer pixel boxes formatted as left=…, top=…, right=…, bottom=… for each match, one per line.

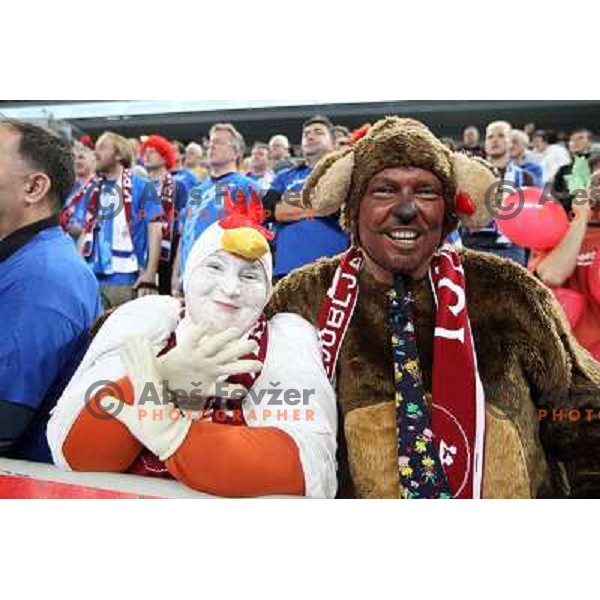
left=267, top=118, right=600, bottom=498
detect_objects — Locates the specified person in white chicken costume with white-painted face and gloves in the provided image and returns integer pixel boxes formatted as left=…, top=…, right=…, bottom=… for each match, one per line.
left=47, top=205, right=337, bottom=498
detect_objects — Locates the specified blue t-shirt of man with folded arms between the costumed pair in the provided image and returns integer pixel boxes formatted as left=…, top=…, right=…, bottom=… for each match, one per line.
left=271, top=165, right=350, bottom=276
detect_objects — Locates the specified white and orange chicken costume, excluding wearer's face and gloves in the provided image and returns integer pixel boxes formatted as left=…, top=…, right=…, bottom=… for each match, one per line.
left=47, top=216, right=337, bottom=498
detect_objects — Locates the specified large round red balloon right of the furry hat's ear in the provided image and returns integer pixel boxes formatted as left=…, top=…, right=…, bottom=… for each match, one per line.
left=496, top=187, right=569, bottom=250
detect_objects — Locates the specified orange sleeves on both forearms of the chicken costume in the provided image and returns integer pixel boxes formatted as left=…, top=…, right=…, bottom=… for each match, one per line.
left=63, top=377, right=304, bottom=496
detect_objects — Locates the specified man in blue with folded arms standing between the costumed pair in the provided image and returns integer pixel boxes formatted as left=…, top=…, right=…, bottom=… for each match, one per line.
left=263, top=115, right=349, bottom=279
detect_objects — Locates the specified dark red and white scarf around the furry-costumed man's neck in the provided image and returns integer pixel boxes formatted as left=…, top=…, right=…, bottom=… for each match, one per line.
left=317, top=244, right=485, bottom=498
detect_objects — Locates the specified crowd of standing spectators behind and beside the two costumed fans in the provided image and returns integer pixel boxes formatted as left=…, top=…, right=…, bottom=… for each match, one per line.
left=0, top=110, right=600, bottom=472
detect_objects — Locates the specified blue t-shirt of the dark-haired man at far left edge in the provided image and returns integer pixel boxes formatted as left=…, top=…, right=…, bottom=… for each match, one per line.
left=0, top=226, right=102, bottom=462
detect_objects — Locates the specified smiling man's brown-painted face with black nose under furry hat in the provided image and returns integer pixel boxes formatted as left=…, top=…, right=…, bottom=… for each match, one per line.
left=358, top=167, right=445, bottom=283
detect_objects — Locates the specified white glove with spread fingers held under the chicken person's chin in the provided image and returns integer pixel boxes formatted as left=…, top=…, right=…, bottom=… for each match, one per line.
left=158, top=324, right=262, bottom=398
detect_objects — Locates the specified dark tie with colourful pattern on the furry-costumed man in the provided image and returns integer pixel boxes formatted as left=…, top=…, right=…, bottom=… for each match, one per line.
left=388, top=275, right=452, bottom=498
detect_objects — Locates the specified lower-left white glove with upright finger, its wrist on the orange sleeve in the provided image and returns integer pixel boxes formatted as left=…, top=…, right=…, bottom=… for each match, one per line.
left=101, top=336, right=192, bottom=461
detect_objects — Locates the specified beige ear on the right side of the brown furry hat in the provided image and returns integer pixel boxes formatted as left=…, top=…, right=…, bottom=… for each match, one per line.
left=452, top=152, right=498, bottom=229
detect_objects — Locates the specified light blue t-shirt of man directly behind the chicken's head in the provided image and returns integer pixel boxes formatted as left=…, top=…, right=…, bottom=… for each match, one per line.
left=180, top=173, right=260, bottom=277
